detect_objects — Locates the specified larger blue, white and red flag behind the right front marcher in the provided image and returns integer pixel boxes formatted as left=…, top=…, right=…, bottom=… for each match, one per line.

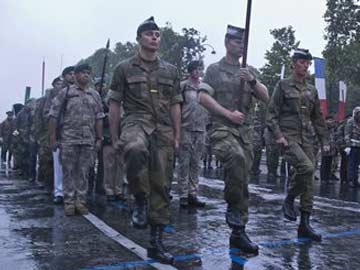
left=314, top=57, right=327, bottom=117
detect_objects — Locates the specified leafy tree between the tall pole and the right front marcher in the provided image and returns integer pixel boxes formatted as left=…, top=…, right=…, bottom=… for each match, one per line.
left=260, top=26, right=300, bottom=95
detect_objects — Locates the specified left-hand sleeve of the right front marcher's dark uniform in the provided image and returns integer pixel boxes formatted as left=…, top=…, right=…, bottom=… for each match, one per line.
left=266, top=82, right=283, bottom=139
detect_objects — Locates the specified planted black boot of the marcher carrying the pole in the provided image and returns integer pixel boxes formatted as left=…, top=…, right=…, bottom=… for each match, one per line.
left=230, top=226, right=259, bottom=254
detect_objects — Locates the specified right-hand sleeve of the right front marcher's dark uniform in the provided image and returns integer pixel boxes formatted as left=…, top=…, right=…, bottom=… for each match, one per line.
left=310, top=89, right=329, bottom=145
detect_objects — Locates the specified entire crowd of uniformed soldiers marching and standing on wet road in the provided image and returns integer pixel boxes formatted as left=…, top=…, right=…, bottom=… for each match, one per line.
left=0, top=17, right=360, bottom=264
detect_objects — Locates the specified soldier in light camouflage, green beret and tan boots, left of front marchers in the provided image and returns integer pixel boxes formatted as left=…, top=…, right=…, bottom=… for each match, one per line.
left=49, top=64, right=105, bottom=216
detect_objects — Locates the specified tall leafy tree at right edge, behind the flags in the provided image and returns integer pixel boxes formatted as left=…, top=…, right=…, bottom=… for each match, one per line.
left=323, top=0, right=360, bottom=114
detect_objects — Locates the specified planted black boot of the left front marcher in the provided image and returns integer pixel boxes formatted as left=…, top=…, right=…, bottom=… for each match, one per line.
left=147, top=225, right=174, bottom=264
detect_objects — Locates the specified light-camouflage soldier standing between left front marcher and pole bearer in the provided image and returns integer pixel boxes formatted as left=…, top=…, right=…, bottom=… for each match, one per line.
left=178, top=61, right=210, bottom=207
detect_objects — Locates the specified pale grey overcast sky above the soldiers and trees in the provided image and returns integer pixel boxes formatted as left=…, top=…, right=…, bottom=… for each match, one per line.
left=0, top=0, right=326, bottom=119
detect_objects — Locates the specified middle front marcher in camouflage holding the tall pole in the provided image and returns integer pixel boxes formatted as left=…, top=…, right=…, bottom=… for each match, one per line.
left=200, top=25, right=269, bottom=254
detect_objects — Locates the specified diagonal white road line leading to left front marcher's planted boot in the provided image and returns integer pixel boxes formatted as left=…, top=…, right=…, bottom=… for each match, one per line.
left=84, top=213, right=178, bottom=270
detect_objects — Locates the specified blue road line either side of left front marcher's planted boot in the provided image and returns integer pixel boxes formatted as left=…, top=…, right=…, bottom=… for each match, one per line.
left=80, top=254, right=201, bottom=270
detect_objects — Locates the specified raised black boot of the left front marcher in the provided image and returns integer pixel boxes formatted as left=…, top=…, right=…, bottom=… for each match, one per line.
left=131, top=193, right=148, bottom=229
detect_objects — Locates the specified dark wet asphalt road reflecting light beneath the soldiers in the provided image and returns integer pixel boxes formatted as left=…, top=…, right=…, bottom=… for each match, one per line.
left=0, top=162, right=360, bottom=270
